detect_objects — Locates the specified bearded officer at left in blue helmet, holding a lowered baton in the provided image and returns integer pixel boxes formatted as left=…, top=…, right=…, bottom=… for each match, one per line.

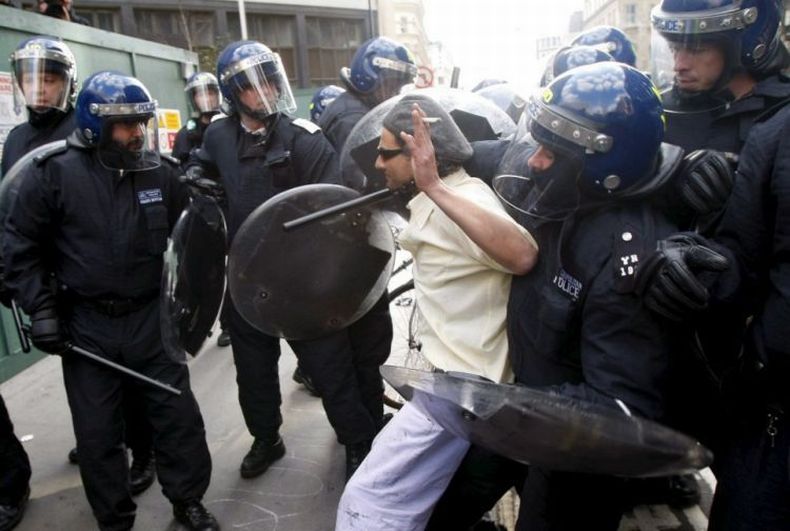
left=3, top=72, right=219, bottom=530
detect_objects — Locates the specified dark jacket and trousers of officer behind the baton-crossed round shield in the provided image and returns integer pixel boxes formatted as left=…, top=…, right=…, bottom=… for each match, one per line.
left=194, top=113, right=389, bottom=445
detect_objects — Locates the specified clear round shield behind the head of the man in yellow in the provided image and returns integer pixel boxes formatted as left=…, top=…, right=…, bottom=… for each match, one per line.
left=340, top=87, right=516, bottom=192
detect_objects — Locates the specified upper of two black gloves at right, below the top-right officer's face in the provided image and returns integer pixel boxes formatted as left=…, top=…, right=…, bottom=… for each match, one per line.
left=679, top=149, right=735, bottom=214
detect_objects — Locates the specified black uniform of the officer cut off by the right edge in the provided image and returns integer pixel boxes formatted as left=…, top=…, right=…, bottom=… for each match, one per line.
left=710, top=102, right=790, bottom=531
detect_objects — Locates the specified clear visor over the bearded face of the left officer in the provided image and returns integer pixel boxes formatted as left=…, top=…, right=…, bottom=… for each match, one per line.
left=97, top=116, right=162, bottom=171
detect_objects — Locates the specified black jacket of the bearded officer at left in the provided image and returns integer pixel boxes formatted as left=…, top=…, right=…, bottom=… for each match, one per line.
left=3, top=135, right=188, bottom=313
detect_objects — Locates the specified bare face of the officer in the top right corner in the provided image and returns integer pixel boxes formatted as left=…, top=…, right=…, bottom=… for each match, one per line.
left=670, top=43, right=724, bottom=92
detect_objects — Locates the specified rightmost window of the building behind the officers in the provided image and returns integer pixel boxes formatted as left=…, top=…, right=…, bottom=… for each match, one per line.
left=307, top=17, right=365, bottom=86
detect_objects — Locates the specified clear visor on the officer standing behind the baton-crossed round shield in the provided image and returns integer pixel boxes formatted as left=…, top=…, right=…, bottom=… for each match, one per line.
left=222, top=54, right=296, bottom=117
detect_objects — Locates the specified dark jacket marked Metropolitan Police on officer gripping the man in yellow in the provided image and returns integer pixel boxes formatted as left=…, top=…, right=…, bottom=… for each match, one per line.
left=507, top=193, right=680, bottom=418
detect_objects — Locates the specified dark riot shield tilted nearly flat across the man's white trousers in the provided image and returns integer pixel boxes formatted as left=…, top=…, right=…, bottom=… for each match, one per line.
left=381, top=365, right=713, bottom=477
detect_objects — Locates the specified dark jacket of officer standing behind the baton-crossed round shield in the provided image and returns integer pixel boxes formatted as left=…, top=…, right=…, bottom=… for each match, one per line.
left=196, top=115, right=340, bottom=238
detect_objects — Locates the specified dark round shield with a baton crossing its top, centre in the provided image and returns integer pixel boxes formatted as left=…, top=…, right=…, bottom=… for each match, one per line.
left=228, top=184, right=395, bottom=339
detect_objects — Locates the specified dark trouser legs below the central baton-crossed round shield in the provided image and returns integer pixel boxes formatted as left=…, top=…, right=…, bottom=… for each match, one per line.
left=228, top=298, right=392, bottom=445
